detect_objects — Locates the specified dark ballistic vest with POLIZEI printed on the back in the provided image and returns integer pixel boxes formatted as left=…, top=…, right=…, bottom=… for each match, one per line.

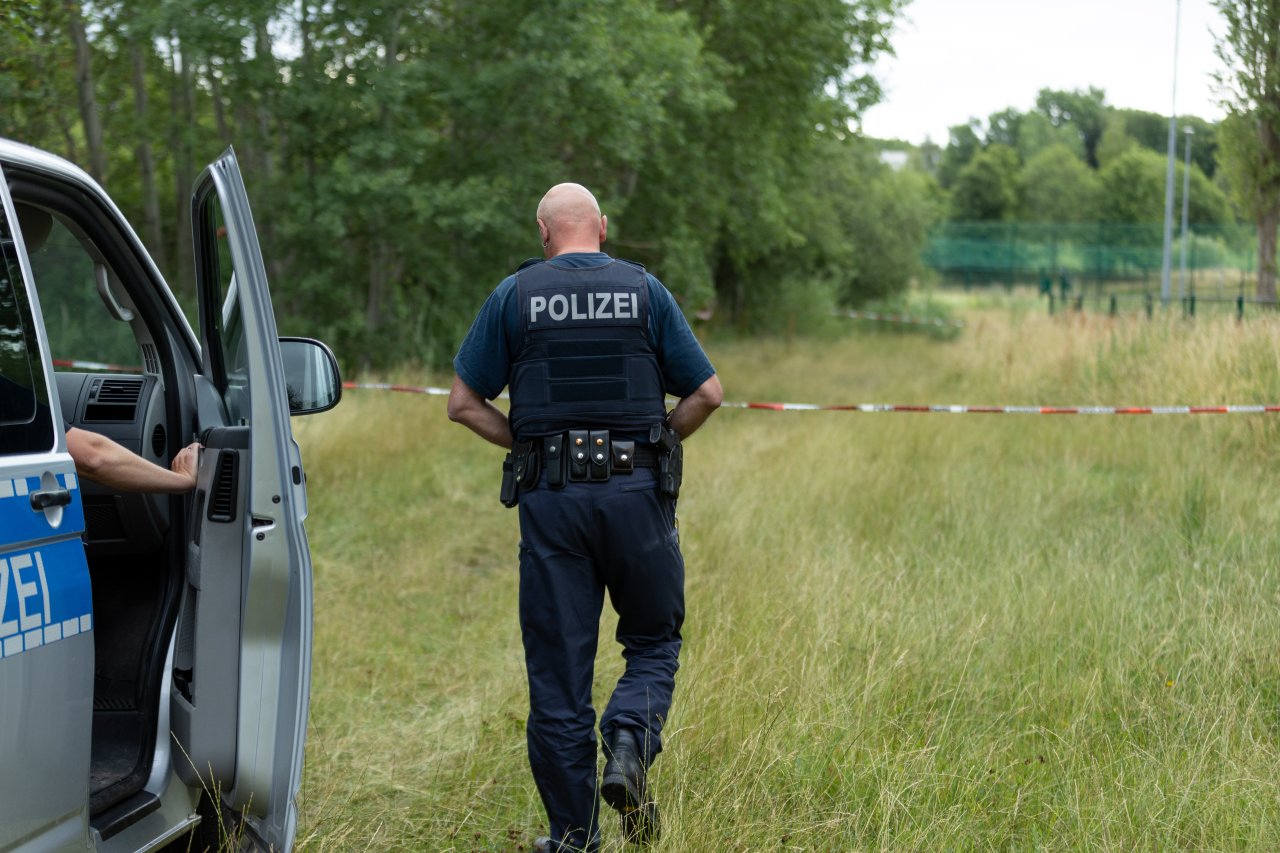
left=508, top=260, right=666, bottom=441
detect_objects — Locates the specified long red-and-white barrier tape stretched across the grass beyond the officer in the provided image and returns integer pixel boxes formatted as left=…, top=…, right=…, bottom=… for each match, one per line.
left=342, top=382, right=1280, bottom=415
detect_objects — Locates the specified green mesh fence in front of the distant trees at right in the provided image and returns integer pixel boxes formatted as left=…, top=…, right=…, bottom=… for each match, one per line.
left=924, top=222, right=1257, bottom=296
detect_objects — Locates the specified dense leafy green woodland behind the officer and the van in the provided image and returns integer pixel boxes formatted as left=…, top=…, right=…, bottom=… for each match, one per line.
left=0, top=0, right=923, bottom=368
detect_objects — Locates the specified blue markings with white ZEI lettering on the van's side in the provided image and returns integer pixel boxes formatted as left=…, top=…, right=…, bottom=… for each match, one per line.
left=0, top=474, right=93, bottom=658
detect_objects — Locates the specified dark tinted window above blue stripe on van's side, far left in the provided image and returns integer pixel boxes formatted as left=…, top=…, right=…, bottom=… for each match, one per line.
left=0, top=207, right=55, bottom=455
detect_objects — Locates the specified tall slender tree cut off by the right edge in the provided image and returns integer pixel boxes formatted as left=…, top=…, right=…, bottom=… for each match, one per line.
left=1215, top=0, right=1280, bottom=301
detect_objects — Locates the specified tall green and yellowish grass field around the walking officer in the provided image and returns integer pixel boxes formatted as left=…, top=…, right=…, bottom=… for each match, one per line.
left=296, top=302, right=1280, bottom=852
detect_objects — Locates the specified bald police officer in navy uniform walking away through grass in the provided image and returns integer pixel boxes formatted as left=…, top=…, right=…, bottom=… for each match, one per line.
left=449, top=183, right=722, bottom=850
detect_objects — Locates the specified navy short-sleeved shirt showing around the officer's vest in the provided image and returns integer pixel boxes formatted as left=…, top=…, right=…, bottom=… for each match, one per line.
left=453, top=252, right=716, bottom=400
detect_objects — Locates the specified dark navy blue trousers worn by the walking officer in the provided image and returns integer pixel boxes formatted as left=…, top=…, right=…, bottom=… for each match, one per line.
left=520, top=469, right=685, bottom=850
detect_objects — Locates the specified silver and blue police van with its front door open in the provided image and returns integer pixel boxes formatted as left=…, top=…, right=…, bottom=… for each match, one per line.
left=0, top=140, right=342, bottom=852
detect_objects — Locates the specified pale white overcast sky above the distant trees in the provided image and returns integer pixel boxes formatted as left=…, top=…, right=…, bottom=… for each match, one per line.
left=863, top=0, right=1224, bottom=145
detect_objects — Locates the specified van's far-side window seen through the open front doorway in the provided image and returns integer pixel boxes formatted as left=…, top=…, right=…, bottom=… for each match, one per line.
left=22, top=207, right=141, bottom=371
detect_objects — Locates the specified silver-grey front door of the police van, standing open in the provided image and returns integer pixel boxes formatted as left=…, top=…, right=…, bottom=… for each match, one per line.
left=170, top=149, right=311, bottom=850
